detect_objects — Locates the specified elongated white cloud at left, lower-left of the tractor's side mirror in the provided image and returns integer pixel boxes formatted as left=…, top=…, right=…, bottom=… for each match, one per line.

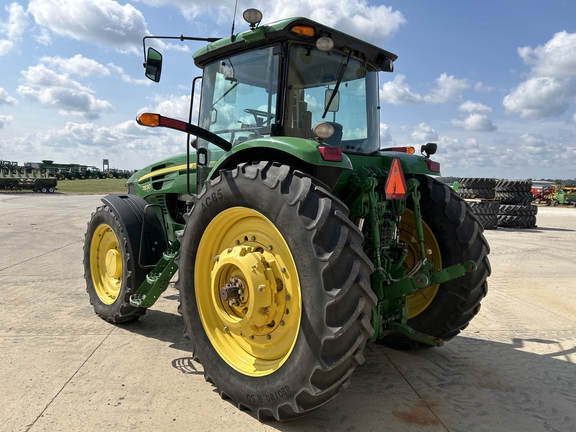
left=16, top=64, right=113, bottom=120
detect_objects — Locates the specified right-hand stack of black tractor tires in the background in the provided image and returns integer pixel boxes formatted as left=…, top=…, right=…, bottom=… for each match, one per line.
left=494, top=180, right=538, bottom=228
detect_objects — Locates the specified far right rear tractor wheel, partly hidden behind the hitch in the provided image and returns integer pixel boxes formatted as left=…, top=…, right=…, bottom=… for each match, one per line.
left=382, top=176, right=490, bottom=349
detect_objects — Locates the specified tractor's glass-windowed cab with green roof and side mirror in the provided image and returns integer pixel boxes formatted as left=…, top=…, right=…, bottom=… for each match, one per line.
left=145, top=9, right=397, bottom=189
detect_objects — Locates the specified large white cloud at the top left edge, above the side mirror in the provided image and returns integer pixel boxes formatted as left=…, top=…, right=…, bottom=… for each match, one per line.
left=28, top=0, right=149, bottom=54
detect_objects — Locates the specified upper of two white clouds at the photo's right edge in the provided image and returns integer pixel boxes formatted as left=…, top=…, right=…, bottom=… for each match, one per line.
left=518, top=31, right=576, bottom=77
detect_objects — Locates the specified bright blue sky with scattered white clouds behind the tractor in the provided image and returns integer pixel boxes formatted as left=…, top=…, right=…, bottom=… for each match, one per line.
left=0, top=0, right=576, bottom=179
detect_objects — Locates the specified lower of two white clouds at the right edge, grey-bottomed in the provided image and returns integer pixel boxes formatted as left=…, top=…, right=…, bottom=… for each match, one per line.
left=502, top=77, right=576, bottom=119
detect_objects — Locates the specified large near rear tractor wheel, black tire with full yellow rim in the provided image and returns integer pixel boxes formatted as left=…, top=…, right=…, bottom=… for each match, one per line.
left=178, top=162, right=376, bottom=421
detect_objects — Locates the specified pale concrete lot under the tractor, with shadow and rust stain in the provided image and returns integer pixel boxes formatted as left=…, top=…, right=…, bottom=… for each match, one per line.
left=0, top=194, right=576, bottom=432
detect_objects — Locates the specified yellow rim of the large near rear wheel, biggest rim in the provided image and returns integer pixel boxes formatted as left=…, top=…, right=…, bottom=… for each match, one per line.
left=194, top=207, right=302, bottom=377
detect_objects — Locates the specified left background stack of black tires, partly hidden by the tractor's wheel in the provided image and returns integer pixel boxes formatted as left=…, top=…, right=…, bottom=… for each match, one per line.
left=458, top=177, right=500, bottom=229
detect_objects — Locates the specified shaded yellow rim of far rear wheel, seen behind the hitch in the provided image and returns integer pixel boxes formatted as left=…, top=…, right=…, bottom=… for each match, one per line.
left=400, top=210, right=442, bottom=319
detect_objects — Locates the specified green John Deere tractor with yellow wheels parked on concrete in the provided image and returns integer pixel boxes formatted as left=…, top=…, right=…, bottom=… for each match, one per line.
left=84, top=9, right=490, bottom=420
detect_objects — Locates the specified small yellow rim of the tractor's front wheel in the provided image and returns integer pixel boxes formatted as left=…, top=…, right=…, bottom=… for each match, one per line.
left=90, top=224, right=122, bottom=305
